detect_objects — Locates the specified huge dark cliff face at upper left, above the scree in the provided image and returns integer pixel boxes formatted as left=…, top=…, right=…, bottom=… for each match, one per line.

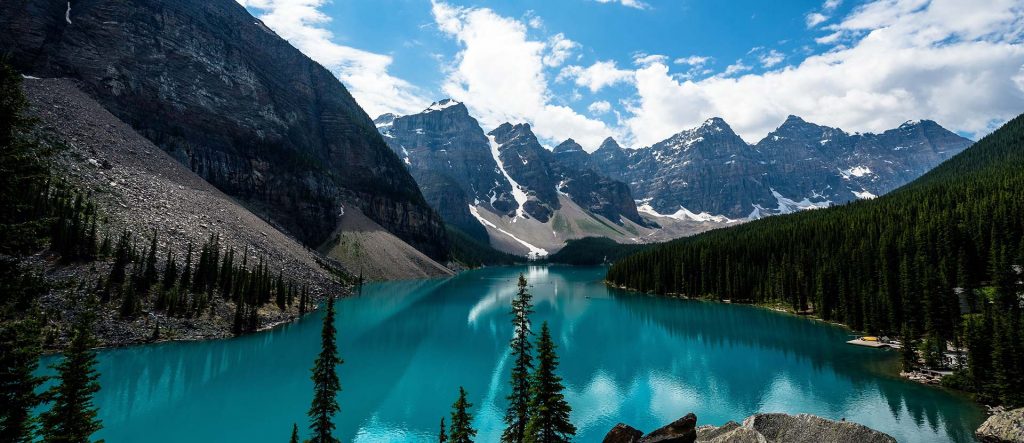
left=0, top=0, right=446, bottom=258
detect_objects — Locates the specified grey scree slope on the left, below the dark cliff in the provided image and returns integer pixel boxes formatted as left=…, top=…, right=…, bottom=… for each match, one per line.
left=25, top=79, right=350, bottom=346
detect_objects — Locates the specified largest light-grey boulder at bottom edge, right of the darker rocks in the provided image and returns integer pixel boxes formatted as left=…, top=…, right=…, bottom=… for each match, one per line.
left=743, top=413, right=896, bottom=443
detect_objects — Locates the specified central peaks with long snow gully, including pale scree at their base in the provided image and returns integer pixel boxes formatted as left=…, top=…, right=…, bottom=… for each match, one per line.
left=374, top=99, right=653, bottom=254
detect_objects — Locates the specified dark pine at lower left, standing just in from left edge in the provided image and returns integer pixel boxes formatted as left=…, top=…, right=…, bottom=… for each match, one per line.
left=41, top=313, right=102, bottom=443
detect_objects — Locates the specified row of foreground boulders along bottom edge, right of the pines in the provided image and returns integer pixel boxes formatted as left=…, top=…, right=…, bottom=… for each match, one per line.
left=604, top=412, right=896, bottom=443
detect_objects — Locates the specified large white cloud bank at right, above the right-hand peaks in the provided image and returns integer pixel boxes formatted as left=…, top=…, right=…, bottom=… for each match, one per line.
left=626, top=0, right=1024, bottom=144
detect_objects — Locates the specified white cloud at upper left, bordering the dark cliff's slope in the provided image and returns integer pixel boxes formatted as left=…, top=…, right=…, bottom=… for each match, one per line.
left=238, top=0, right=430, bottom=117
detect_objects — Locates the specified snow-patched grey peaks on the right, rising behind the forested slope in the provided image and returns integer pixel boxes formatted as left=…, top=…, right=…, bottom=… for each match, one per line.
left=589, top=116, right=972, bottom=219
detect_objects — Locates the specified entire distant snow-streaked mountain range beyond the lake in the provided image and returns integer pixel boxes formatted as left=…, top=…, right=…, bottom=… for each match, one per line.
left=375, top=99, right=972, bottom=256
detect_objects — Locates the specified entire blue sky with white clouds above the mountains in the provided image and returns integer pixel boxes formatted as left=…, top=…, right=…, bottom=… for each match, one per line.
left=239, top=0, right=1024, bottom=149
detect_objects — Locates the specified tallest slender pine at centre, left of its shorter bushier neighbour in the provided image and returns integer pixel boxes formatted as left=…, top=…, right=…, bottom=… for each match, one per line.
left=502, top=274, right=534, bottom=443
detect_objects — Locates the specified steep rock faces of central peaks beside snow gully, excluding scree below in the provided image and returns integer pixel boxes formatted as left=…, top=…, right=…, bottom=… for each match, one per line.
left=374, top=104, right=647, bottom=235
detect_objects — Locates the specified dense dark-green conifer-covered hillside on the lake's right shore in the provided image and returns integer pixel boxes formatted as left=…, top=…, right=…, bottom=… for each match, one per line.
left=607, top=116, right=1024, bottom=404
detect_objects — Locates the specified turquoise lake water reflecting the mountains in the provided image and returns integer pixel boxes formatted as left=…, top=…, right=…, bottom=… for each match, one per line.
left=37, top=266, right=983, bottom=443
